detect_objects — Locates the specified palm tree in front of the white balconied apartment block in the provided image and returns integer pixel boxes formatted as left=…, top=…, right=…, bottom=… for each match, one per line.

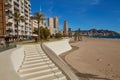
left=12, top=12, right=25, bottom=42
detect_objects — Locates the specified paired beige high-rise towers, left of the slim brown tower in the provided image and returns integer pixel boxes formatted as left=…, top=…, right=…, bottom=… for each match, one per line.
left=48, top=17, right=58, bottom=34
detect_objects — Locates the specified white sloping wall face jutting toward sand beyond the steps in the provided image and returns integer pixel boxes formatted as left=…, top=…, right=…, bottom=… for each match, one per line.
left=44, top=39, right=72, bottom=55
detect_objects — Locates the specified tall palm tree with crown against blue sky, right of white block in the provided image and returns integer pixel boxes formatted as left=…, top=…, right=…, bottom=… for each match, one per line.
left=34, top=12, right=45, bottom=41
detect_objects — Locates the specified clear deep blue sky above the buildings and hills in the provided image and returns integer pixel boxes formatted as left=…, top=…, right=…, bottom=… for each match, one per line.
left=30, top=0, right=120, bottom=33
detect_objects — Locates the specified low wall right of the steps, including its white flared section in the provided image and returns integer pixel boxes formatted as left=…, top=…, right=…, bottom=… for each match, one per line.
left=42, top=40, right=79, bottom=80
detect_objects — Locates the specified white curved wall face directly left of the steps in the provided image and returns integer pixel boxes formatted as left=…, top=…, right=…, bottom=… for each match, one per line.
left=10, top=47, right=24, bottom=72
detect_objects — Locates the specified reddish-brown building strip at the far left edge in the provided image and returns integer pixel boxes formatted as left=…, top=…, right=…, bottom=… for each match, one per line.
left=0, top=0, right=6, bottom=35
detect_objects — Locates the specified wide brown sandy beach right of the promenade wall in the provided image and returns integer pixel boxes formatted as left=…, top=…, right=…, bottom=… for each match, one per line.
left=60, top=38, right=120, bottom=80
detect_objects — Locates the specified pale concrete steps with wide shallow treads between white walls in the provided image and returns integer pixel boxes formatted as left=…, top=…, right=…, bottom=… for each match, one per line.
left=18, top=44, right=67, bottom=80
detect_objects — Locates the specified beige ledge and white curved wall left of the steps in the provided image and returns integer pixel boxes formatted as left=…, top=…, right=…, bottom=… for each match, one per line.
left=0, top=47, right=24, bottom=80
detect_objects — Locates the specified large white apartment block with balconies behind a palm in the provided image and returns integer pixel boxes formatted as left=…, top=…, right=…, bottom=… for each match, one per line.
left=5, top=0, right=32, bottom=36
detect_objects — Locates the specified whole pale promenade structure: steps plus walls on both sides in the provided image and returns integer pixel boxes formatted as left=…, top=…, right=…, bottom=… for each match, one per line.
left=0, top=40, right=79, bottom=80
